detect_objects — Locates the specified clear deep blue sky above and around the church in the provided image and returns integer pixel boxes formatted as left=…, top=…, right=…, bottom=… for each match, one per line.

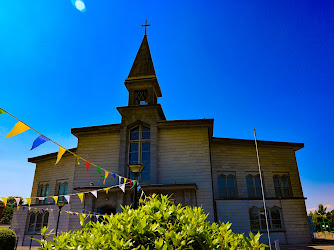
left=0, top=0, right=334, bottom=211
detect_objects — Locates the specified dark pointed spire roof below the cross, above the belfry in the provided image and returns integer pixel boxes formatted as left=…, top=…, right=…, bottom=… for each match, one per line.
left=128, top=34, right=155, bottom=78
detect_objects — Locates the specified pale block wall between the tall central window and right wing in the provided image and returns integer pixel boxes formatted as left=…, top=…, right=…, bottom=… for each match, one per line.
left=158, top=127, right=214, bottom=221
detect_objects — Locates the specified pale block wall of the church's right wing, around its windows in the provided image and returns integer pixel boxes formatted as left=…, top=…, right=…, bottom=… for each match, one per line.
left=211, top=143, right=311, bottom=244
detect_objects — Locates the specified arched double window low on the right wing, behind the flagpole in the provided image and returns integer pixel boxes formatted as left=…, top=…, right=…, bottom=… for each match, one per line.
left=249, top=207, right=283, bottom=230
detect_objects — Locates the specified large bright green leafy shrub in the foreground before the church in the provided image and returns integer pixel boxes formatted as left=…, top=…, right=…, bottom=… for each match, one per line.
left=36, top=195, right=266, bottom=250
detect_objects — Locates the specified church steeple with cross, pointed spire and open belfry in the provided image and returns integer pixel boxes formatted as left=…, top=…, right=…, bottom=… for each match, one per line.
left=124, top=24, right=162, bottom=106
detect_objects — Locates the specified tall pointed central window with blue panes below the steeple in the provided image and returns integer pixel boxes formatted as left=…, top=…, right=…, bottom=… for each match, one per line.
left=129, top=125, right=151, bottom=181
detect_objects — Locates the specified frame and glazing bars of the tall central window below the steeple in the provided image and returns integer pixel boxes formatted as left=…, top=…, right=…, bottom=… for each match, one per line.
left=127, top=123, right=151, bottom=182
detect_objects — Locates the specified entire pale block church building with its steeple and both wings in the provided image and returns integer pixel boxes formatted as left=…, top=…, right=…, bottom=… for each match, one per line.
left=11, top=34, right=311, bottom=245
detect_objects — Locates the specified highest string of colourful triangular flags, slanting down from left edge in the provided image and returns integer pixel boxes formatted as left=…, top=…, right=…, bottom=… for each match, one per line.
left=0, top=108, right=142, bottom=189
